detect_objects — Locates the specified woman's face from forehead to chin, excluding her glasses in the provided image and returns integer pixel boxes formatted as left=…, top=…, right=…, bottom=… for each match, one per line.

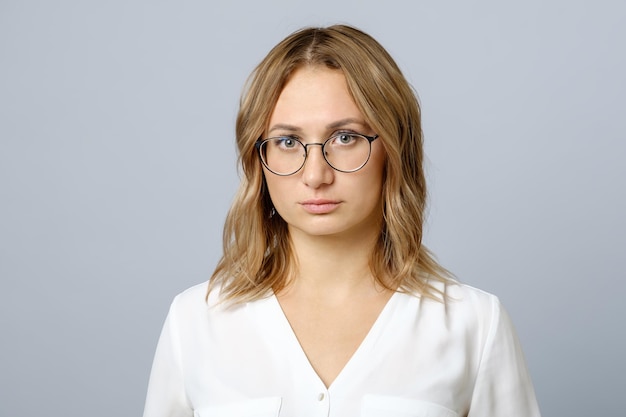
left=264, top=66, right=385, bottom=239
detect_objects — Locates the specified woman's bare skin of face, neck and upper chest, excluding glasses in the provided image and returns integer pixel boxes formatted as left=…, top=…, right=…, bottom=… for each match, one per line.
left=264, top=66, right=391, bottom=387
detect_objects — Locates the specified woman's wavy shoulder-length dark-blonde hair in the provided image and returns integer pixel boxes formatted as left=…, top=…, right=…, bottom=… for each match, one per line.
left=207, top=25, right=451, bottom=304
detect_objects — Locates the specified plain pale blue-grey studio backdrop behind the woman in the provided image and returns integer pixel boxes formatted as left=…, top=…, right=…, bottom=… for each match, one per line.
left=0, top=0, right=626, bottom=417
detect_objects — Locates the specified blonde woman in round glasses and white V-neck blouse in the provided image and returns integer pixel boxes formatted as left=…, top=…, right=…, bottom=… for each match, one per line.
left=144, top=26, right=539, bottom=417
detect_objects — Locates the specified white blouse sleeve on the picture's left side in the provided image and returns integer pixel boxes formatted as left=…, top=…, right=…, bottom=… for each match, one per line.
left=143, top=300, right=193, bottom=417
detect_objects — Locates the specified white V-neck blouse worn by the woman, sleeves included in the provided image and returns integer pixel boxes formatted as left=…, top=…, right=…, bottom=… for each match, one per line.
left=144, top=283, right=540, bottom=417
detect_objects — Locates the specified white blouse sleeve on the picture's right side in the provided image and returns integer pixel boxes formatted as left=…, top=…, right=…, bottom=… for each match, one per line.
left=468, top=297, right=540, bottom=417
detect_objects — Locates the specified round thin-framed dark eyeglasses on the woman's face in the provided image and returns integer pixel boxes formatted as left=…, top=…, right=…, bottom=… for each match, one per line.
left=255, top=133, right=378, bottom=176
